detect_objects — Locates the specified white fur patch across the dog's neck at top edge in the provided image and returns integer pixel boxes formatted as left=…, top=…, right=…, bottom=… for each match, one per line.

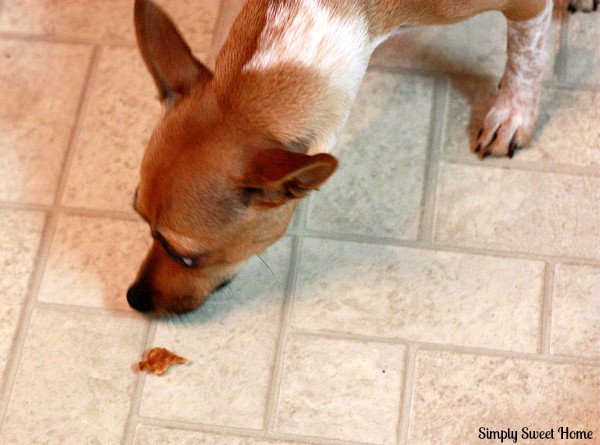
left=243, top=0, right=381, bottom=99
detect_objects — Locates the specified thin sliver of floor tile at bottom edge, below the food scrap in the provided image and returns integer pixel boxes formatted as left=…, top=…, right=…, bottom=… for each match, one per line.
left=133, top=425, right=302, bottom=445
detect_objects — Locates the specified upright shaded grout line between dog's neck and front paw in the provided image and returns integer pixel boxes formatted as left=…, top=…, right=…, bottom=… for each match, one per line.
left=417, top=78, right=450, bottom=242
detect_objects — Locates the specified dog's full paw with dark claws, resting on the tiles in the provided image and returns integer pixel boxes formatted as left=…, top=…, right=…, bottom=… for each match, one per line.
left=473, top=88, right=538, bottom=159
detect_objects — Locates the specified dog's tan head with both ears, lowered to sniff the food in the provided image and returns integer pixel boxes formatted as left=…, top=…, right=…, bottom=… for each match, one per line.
left=127, top=0, right=337, bottom=313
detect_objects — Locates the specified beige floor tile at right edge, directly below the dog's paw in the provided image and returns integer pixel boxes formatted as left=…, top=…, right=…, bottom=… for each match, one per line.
left=434, top=164, right=600, bottom=258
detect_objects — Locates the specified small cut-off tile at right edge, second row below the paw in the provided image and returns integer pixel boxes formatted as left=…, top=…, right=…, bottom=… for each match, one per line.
left=551, top=264, right=600, bottom=358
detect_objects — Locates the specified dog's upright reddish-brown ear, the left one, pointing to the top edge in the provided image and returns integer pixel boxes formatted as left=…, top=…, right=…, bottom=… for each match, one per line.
left=134, top=0, right=212, bottom=104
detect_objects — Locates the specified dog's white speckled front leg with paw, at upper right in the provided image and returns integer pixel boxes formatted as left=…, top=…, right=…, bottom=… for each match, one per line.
left=474, top=0, right=553, bottom=158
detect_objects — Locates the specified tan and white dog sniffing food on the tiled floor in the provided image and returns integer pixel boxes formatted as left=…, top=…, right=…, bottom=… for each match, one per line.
left=127, top=0, right=585, bottom=314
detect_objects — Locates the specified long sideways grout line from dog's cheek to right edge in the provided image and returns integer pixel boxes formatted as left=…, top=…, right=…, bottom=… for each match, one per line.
left=304, top=230, right=600, bottom=267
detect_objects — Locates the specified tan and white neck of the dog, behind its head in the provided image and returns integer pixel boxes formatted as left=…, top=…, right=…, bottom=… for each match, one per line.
left=216, top=0, right=383, bottom=154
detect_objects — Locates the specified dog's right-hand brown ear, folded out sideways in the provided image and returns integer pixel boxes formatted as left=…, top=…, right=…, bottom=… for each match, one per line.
left=243, top=148, right=338, bottom=207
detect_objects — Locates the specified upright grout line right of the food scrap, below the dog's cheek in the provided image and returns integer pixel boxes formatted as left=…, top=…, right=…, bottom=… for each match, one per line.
left=263, top=236, right=303, bottom=434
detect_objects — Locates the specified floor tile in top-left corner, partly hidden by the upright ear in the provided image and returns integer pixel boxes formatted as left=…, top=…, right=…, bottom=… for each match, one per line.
left=0, top=0, right=219, bottom=48
